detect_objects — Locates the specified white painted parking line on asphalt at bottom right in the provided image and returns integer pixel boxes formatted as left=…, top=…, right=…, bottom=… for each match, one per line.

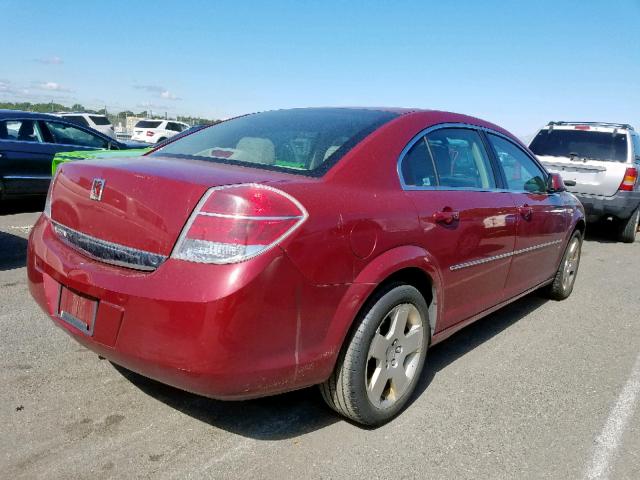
left=585, top=355, right=640, bottom=480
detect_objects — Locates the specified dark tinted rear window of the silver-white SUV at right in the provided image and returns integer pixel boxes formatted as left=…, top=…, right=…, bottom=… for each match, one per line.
left=529, top=129, right=627, bottom=162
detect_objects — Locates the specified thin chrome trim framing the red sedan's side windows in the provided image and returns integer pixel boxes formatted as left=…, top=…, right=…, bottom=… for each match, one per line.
left=396, top=122, right=550, bottom=195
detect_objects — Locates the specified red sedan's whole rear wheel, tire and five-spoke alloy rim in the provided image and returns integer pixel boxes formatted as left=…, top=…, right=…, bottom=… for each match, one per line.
left=320, top=283, right=431, bottom=425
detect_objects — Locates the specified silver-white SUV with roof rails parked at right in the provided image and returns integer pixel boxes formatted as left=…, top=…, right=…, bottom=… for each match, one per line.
left=529, top=122, right=640, bottom=243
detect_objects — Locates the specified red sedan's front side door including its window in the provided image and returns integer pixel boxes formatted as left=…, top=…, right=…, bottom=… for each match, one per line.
left=487, top=133, right=569, bottom=297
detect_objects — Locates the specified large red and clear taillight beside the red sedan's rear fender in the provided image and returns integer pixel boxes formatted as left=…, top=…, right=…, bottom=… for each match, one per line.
left=172, top=184, right=307, bottom=264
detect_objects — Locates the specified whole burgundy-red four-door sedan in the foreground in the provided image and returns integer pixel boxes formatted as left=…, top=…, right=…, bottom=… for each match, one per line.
left=28, top=108, right=585, bottom=425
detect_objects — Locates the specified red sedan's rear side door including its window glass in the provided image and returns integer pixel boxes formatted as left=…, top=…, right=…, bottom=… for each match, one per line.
left=400, top=127, right=516, bottom=331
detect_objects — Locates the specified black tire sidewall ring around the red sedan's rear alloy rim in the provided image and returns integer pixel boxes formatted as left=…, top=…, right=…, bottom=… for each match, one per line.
left=347, top=284, right=431, bottom=425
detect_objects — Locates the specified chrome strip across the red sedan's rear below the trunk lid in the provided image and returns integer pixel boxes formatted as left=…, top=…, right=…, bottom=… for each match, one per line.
left=51, top=220, right=167, bottom=271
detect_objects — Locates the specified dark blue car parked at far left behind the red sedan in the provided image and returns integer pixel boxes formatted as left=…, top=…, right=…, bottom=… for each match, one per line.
left=0, top=110, right=144, bottom=199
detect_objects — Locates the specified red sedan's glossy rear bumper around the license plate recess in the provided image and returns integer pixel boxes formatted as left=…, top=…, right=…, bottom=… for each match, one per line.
left=27, top=217, right=341, bottom=399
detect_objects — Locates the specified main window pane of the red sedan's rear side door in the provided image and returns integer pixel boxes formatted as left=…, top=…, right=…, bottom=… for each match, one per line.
left=426, top=128, right=496, bottom=189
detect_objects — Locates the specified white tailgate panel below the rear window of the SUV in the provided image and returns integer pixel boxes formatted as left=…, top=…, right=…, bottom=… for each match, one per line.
left=538, top=155, right=628, bottom=196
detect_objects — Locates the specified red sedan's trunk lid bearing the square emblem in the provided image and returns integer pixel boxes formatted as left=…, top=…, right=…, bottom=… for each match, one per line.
left=51, top=156, right=298, bottom=263
